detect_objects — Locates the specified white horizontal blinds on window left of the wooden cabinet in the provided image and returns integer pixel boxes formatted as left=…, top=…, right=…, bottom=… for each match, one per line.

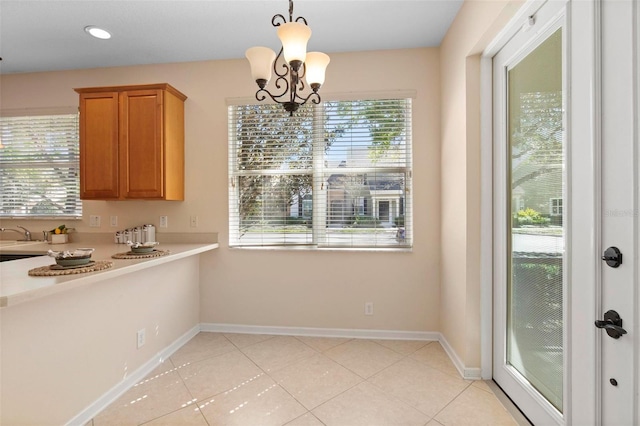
left=0, top=113, right=82, bottom=217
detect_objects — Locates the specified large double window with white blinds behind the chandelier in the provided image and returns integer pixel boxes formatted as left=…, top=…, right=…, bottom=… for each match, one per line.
left=229, top=99, right=412, bottom=248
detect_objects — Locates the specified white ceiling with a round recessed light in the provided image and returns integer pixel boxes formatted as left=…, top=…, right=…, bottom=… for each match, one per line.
left=0, top=0, right=463, bottom=74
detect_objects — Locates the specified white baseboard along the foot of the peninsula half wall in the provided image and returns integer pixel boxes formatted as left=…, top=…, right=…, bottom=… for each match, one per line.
left=67, top=325, right=200, bottom=426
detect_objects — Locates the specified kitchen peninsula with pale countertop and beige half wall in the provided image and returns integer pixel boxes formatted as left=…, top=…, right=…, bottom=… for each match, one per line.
left=0, top=238, right=218, bottom=425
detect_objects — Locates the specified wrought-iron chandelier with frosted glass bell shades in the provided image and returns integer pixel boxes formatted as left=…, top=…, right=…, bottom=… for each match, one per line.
left=245, top=0, right=329, bottom=115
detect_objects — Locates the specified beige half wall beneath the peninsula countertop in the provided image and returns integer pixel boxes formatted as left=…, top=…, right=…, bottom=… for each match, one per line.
left=0, top=256, right=199, bottom=425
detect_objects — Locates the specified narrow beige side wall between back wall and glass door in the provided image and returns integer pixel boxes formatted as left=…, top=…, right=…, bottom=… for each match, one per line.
left=440, top=0, right=522, bottom=368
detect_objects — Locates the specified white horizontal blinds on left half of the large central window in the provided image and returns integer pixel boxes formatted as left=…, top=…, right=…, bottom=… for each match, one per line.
left=229, top=104, right=313, bottom=246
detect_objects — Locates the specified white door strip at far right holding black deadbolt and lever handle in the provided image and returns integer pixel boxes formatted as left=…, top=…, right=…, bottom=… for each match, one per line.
left=597, top=0, right=640, bottom=424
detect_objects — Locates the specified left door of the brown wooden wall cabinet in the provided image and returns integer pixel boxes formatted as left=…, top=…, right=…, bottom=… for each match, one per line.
left=80, top=92, right=119, bottom=200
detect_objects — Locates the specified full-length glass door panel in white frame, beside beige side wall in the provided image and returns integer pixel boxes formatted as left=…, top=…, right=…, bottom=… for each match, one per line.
left=494, top=2, right=568, bottom=424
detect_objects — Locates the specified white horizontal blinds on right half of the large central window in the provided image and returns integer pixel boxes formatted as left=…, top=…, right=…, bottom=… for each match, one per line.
left=316, top=99, right=412, bottom=247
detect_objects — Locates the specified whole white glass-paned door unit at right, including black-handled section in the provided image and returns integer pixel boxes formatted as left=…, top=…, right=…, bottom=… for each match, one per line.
left=493, top=0, right=640, bottom=425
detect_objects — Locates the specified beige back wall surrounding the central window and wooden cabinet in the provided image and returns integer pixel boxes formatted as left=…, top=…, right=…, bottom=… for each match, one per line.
left=0, top=48, right=440, bottom=331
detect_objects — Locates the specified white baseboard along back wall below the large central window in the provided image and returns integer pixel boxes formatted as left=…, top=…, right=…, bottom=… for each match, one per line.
left=200, top=323, right=440, bottom=341
